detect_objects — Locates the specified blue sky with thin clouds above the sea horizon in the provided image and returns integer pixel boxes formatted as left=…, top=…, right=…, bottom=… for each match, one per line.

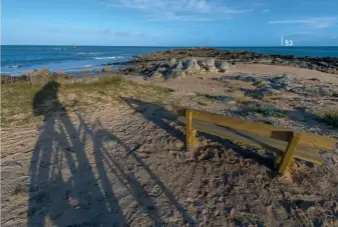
left=1, top=0, right=338, bottom=46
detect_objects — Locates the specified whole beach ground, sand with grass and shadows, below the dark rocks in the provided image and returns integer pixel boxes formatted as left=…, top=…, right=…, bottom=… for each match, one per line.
left=1, top=49, right=338, bottom=227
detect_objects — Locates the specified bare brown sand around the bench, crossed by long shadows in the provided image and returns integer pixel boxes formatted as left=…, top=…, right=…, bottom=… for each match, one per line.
left=1, top=65, right=338, bottom=227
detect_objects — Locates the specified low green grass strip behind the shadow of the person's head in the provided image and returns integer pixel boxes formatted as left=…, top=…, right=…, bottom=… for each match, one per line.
left=1, top=76, right=173, bottom=127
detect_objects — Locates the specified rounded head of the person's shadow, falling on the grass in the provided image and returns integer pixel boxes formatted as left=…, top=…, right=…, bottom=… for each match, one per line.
left=32, top=80, right=62, bottom=116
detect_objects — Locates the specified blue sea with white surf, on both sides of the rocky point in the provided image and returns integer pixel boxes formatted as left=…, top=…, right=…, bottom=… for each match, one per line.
left=1, top=45, right=338, bottom=75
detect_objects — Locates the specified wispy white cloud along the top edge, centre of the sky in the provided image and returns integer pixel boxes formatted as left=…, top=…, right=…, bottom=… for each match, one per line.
left=103, top=0, right=251, bottom=21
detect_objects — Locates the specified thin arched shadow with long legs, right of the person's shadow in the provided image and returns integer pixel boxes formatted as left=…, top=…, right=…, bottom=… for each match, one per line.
left=80, top=117, right=196, bottom=226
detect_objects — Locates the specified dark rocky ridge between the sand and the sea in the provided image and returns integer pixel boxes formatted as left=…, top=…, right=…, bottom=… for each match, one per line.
left=111, top=48, right=338, bottom=75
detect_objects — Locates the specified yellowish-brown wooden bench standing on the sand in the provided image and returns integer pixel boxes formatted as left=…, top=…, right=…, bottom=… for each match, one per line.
left=172, top=106, right=337, bottom=173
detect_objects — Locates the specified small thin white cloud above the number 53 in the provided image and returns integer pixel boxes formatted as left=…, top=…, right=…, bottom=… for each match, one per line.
left=269, top=17, right=337, bottom=29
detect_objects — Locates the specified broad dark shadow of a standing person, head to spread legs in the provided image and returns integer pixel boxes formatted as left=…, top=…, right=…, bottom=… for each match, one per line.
left=28, top=80, right=128, bottom=227
